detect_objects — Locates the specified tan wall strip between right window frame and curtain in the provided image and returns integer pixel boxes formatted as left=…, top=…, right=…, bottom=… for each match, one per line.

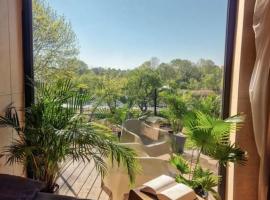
left=226, top=0, right=259, bottom=200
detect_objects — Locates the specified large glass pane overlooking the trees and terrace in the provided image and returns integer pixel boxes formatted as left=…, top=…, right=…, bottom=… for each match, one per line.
left=33, top=0, right=230, bottom=199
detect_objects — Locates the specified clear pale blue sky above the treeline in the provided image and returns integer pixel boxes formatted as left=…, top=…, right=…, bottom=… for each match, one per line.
left=48, top=0, right=227, bottom=69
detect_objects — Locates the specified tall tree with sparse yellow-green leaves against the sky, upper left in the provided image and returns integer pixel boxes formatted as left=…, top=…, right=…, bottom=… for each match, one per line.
left=33, top=0, right=79, bottom=80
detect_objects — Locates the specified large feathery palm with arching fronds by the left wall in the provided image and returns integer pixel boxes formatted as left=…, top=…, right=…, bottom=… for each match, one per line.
left=0, top=80, right=138, bottom=192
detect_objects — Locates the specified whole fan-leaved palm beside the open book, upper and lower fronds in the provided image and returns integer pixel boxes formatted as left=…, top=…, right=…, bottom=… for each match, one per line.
left=170, top=112, right=246, bottom=199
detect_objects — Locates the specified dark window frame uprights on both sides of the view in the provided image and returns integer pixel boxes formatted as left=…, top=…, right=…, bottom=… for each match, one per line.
left=22, top=0, right=238, bottom=199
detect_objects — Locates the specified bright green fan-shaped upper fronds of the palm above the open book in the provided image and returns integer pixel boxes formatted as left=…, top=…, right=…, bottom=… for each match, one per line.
left=185, top=112, right=246, bottom=166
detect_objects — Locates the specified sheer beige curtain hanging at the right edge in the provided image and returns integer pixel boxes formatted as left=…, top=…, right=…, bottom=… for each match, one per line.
left=249, top=0, right=270, bottom=200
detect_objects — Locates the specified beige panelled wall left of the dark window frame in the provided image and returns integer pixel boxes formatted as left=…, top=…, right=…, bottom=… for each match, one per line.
left=0, top=0, right=24, bottom=175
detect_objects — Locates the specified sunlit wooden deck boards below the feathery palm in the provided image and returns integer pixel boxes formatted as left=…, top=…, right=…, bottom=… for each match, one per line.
left=57, top=160, right=110, bottom=200
